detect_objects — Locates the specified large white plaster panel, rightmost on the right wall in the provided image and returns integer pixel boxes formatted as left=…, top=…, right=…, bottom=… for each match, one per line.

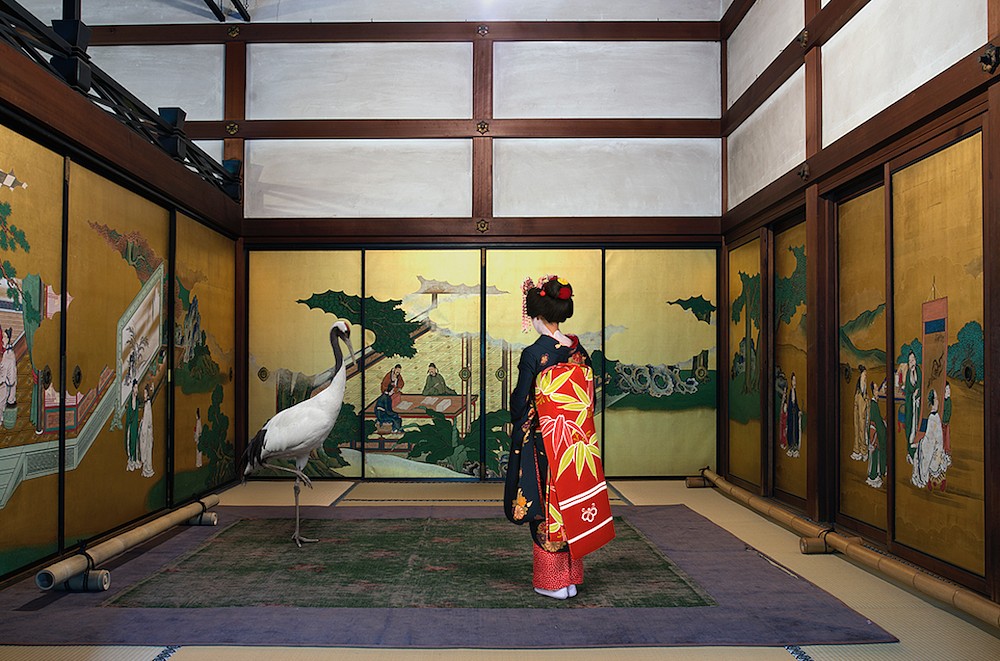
left=823, top=0, right=989, bottom=147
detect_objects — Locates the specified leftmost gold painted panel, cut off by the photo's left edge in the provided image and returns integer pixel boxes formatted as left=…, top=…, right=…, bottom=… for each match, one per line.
left=0, top=127, right=63, bottom=576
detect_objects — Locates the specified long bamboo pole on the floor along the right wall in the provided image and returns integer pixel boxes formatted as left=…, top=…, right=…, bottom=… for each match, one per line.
left=701, top=468, right=1000, bottom=628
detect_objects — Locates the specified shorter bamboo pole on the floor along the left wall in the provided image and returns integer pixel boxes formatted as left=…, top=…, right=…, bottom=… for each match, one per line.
left=35, top=494, right=219, bottom=590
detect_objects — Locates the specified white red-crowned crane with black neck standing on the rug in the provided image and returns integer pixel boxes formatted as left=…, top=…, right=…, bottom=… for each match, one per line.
left=243, top=320, right=354, bottom=548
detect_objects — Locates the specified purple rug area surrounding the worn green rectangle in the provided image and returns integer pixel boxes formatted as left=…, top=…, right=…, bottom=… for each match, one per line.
left=0, top=505, right=896, bottom=649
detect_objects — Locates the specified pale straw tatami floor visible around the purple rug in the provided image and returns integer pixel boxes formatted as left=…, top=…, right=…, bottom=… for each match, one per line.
left=0, top=480, right=1000, bottom=661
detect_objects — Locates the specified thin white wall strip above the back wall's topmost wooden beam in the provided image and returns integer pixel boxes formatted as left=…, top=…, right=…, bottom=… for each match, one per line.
left=21, top=0, right=732, bottom=25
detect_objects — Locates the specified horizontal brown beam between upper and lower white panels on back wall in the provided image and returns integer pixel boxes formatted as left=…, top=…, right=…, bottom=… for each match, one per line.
left=184, top=117, right=720, bottom=140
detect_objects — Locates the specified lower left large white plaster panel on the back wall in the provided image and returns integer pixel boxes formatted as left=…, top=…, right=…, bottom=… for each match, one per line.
left=244, top=140, right=472, bottom=218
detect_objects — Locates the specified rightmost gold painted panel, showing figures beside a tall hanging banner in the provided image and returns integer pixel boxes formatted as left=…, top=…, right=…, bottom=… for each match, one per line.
left=891, top=133, right=986, bottom=575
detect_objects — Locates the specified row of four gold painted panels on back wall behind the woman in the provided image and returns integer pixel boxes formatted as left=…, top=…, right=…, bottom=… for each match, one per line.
left=249, top=248, right=717, bottom=479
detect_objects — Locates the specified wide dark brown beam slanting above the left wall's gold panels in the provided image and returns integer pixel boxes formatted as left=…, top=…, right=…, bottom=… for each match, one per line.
left=0, top=43, right=242, bottom=235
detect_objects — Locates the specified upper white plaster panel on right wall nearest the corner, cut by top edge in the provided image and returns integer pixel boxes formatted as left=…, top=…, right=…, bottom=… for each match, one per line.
left=726, top=0, right=806, bottom=106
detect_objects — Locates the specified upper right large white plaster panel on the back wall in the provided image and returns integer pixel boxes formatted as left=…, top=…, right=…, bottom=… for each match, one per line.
left=493, top=41, right=721, bottom=118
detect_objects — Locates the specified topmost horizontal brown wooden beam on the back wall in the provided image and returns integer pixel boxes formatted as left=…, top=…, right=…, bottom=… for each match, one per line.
left=90, top=21, right=721, bottom=46
